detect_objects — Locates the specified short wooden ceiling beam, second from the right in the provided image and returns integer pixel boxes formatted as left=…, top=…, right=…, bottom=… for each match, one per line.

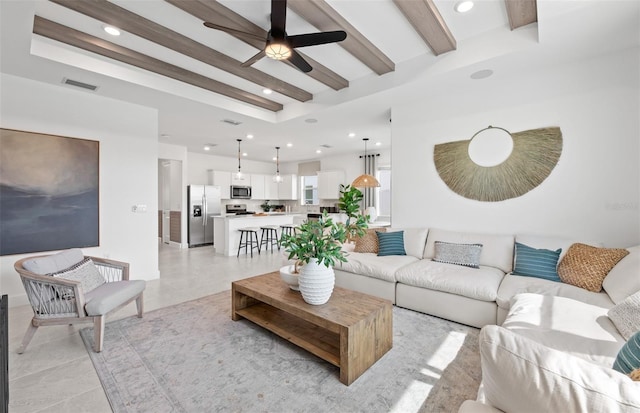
left=393, top=0, right=456, bottom=56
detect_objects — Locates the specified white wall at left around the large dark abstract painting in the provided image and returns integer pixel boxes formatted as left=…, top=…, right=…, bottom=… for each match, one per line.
left=0, top=74, right=159, bottom=306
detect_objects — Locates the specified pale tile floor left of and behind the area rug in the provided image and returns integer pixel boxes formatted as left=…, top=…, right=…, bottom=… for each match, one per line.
left=9, top=244, right=284, bottom=413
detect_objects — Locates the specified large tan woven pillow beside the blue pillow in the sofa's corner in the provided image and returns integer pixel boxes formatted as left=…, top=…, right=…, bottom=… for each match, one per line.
left=558, top=243, right=629, bottom=293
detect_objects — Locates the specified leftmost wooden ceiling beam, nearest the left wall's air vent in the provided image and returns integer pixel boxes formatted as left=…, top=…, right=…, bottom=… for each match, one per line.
left=33, top=16, right=283, bottom=112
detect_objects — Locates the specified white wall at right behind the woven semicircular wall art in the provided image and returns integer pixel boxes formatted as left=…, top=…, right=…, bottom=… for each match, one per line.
left=392, top=49, right=640, bottom=247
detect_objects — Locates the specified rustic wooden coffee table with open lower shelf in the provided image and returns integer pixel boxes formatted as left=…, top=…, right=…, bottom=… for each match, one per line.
left=231, top=272, right=393, bottom=386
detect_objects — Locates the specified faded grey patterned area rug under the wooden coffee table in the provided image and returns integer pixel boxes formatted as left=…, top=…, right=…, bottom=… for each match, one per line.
left=80, top=291, right=481, bottom=413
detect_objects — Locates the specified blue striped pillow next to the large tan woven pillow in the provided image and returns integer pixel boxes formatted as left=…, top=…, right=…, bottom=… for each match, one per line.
left=512, top=242, right=562, bottom=282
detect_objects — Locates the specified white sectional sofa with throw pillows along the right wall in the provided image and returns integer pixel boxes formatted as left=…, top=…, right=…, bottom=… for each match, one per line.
left=334, top=229, right=640, bottom=413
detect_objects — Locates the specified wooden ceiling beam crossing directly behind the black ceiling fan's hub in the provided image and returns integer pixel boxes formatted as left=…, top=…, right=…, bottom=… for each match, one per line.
left=165, top=0, right=349, bottom=90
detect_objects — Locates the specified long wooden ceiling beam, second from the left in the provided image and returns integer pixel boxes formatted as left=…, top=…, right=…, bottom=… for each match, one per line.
left=50, top=0, right=313, bottom=102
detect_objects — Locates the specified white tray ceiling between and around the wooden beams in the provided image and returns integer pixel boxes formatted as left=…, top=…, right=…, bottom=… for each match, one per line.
left=0, top=0, right=640, bottom=162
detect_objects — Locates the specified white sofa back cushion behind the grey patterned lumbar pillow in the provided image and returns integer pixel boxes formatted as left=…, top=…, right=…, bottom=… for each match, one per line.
left=423, top=228, right=514, bottom=273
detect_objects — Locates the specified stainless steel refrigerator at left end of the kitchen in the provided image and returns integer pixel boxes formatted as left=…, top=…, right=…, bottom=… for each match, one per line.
left=187, top=185, right=221, bottom=248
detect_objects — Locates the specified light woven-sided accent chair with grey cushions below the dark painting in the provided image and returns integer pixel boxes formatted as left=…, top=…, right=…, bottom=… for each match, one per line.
left=14, top=252, right=146, bottom=354
